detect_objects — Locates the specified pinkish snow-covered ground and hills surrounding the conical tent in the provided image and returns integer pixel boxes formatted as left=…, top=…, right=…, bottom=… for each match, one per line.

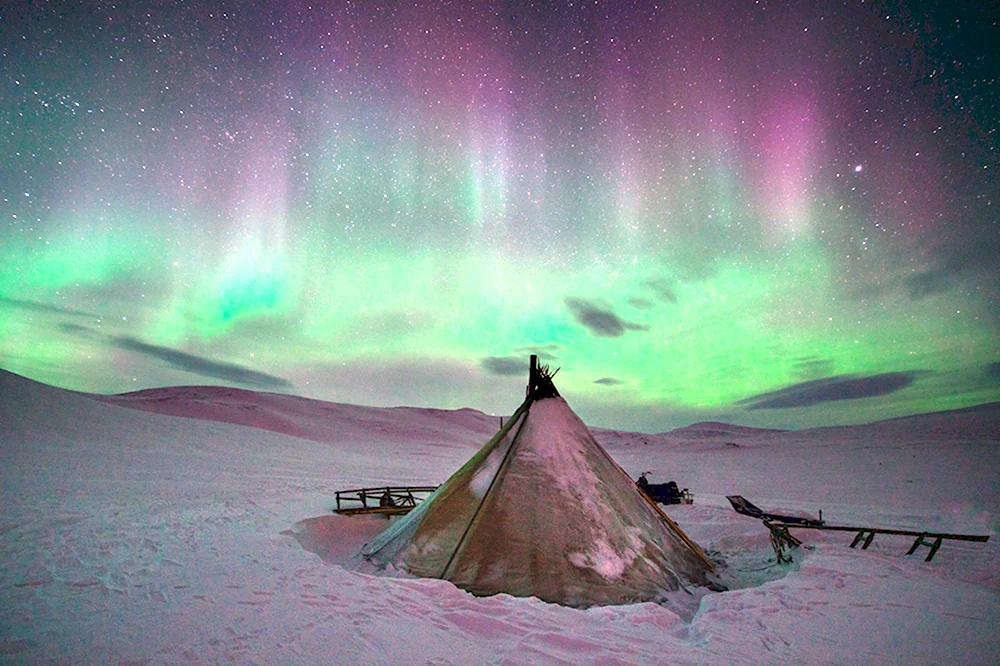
left=0, top=371, right=1000, bottom=664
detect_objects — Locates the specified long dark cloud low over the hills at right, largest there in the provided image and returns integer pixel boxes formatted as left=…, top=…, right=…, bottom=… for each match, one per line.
left=737, top=372, right=917, bottom=409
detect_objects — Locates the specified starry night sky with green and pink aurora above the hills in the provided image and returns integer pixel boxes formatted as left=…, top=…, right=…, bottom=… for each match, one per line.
left=0, top=0, right=1000, bottom=432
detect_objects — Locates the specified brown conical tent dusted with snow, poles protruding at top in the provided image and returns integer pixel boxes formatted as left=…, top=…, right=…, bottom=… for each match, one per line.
left=362, top=357, right=711, bottom=607
